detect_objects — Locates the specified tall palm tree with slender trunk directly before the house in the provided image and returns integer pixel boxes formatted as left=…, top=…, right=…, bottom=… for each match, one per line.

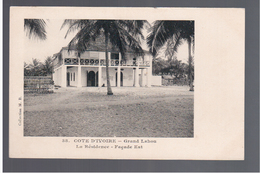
left=61, top=20, right=148, bottom=95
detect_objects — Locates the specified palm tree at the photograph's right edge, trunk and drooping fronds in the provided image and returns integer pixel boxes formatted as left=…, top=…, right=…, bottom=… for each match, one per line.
left=147, top=20, right=194, bottom=91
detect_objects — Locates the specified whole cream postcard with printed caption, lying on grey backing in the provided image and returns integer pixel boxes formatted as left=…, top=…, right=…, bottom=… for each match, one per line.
left=9, top=7, right=245, bottom=160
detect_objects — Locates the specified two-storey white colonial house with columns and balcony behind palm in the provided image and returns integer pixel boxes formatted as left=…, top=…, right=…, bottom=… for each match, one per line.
left=53, top=36, right=156, bottom=87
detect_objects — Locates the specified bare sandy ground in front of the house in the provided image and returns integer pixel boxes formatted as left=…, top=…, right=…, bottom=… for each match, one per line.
left=24, top=86, right=194, bottom=137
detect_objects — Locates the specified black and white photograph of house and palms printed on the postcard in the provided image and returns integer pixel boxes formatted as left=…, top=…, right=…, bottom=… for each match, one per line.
left=24, top=19, right=195, bottom=138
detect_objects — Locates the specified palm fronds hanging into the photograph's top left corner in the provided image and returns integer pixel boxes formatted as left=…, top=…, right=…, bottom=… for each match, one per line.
left=24, top=19, right=47, bottom=40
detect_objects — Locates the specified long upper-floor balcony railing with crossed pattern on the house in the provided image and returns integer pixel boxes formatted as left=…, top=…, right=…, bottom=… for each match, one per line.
left=64, top=58, right=150, bottom=67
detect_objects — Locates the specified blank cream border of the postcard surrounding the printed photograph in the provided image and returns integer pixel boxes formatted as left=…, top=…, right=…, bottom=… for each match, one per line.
left=9, top=7, right=245, bottom=160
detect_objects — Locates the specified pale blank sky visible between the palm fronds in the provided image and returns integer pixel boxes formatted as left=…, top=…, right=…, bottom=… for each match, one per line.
left=24, top=19, right=188, bottom=63
